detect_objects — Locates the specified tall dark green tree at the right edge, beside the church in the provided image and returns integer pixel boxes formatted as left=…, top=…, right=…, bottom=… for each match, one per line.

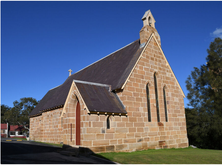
left=186, top=38, right=222, bottom=149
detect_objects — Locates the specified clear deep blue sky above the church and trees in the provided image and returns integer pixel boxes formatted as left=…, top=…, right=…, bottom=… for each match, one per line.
left=1, top=1, right=222, bottom=107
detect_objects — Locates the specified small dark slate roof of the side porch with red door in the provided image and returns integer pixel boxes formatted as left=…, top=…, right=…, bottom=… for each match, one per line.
left=74, top=80, right=127, bottom=115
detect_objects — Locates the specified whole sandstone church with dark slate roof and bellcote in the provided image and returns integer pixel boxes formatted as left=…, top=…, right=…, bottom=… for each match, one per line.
left=30, top=10, right=188, bottom=152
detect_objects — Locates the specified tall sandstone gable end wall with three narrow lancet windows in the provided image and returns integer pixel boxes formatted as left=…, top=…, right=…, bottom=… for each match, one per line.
left=115, top=38, right=188, bottom=151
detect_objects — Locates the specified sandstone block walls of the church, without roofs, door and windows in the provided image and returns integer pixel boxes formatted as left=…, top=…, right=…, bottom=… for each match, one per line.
left=30, top=35, right=188, bottom=152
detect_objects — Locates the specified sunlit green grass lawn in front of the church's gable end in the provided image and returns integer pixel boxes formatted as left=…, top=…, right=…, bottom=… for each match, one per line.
left=97, top=147, right=222, bottom=164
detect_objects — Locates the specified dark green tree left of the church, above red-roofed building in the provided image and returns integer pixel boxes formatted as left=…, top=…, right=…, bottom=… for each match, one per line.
left=1, top=97, right=38, bottom=125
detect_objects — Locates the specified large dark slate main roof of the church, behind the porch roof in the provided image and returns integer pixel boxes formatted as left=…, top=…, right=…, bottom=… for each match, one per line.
left=29, top=39, right=144, bottom=116
